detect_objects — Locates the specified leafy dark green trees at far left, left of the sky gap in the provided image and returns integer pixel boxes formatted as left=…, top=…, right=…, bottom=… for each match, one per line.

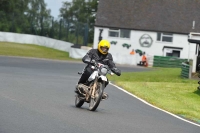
left=0, top=0, right=52, bottom=35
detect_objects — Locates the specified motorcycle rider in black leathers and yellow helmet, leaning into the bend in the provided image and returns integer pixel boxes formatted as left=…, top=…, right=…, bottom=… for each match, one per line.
left=75, top=40, right=121, bottom=99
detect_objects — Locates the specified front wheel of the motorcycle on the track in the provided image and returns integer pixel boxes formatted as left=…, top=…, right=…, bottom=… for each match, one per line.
left=89, top=82, right=105, bottom=111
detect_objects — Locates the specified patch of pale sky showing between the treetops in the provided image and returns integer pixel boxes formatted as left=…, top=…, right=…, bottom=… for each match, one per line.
left=44, top=0, right=72, bottom=18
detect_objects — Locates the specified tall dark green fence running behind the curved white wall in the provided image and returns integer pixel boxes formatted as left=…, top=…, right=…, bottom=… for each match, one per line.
left=0, top=11, right=90, bottom=46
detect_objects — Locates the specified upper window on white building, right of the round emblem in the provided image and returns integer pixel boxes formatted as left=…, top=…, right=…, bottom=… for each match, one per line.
left=157, top=32, right=173, bottom=42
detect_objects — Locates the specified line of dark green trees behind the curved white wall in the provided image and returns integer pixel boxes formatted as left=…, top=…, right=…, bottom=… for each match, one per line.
left=0, top=0, right=98, bottom=45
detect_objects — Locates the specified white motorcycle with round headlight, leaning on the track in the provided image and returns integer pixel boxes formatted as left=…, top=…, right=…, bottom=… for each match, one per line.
left=75, top=60, right=114, bottom=111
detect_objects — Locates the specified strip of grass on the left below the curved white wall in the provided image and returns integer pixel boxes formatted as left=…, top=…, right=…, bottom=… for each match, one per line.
left=0, top=42, right=79, bottom=61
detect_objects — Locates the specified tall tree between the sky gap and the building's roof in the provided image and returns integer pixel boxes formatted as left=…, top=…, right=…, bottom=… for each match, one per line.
left=60, top=0, right=98, bottom=43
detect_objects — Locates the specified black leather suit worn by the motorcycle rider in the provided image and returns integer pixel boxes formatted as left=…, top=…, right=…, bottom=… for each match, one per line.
left=78, top=49, right=121, bottom=84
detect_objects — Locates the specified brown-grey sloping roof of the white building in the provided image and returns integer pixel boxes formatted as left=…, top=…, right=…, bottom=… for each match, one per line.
left=95, top=0, right=200, bottom=34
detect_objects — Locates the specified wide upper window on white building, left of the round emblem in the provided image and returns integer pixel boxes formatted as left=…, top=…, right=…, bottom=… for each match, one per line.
left=109, top=29, right=131, bottom=38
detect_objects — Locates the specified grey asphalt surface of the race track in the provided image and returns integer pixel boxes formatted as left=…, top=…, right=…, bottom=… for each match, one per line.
left=0, top=56, right=200, bottom=133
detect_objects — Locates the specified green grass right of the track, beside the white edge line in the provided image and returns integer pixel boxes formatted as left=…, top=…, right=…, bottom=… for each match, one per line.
left=109, top=68, right=200, bottom=122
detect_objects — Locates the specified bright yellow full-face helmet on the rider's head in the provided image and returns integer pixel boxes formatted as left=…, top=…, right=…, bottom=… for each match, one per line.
left=98, top=40, right=110, bottom=54
